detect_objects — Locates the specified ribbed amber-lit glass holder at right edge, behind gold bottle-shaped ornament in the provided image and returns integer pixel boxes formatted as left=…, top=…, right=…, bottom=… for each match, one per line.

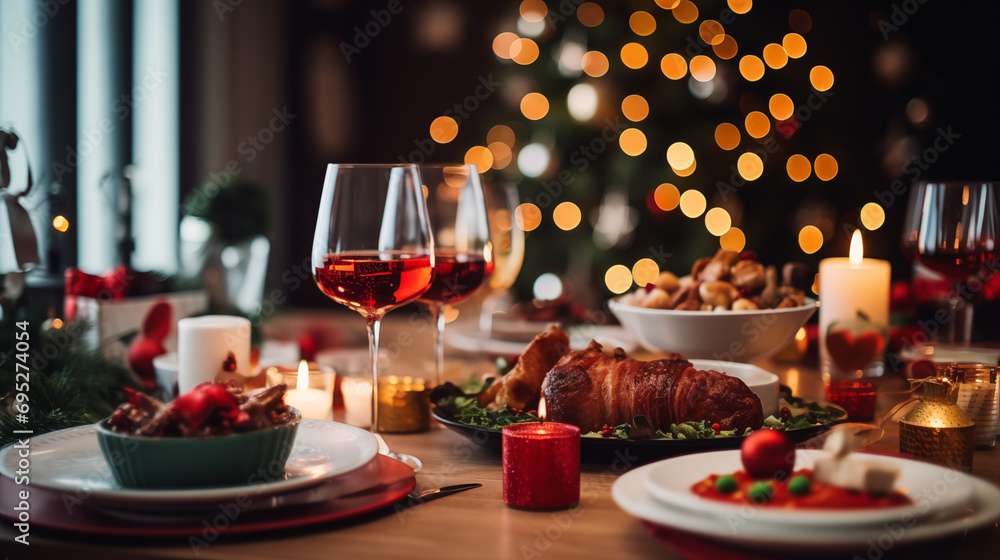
left=946, top=364, right=1000, bottom=449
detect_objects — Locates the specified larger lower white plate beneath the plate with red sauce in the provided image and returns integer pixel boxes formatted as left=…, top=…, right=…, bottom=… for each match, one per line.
left=611, top=463, right=1000, bottom=556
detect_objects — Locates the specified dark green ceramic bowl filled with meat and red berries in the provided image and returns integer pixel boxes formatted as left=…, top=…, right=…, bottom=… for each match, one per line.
left=97, top=408, right=302, bottom=489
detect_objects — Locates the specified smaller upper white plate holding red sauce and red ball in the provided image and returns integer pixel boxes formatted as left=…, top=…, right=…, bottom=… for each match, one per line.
left=646, top=449, right=972, bottom=527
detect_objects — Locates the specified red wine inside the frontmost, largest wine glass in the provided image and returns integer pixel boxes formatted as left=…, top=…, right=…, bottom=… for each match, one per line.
left=315, top=251, right=434, bottom=311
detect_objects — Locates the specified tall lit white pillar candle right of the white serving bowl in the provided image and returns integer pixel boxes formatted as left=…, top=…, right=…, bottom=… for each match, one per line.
left=819, top=230, right=891, bottom=381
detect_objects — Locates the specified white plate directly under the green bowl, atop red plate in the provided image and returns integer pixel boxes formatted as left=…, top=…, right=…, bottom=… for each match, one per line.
left=0, top=420, right=378, bottom=509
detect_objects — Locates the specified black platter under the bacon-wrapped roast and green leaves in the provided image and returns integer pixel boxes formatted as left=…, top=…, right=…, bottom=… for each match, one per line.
left=431, top=405, right=847, bottom=467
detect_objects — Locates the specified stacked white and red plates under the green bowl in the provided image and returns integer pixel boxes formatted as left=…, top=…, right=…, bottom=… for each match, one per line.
left=0, top=420, right=415, bottom=536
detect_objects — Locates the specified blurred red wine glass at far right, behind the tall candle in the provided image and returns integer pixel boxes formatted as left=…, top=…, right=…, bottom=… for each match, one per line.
left=902, top=181, right=1000, bottom=344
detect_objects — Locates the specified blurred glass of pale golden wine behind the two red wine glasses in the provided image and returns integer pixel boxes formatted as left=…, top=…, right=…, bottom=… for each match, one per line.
left=479, top=182, right=524, bottom=338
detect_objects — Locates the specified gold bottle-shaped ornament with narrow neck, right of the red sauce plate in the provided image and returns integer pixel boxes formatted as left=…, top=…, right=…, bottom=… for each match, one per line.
left=899, top=377, right=976, bottom=472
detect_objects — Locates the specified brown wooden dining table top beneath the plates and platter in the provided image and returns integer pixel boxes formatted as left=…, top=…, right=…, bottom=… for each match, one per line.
left=0, top=318, right=1000, bottom=560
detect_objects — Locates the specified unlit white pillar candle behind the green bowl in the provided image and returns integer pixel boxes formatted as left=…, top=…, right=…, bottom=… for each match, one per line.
left=177, top=315, right=250, bottom=394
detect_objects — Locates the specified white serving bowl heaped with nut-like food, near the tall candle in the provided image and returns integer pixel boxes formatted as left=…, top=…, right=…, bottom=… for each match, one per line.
left=608, top=298, right=819, bottom=362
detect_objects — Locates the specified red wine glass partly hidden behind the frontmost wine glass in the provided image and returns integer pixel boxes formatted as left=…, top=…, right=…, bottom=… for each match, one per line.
left=419, top=164, right=493, bottom=385
